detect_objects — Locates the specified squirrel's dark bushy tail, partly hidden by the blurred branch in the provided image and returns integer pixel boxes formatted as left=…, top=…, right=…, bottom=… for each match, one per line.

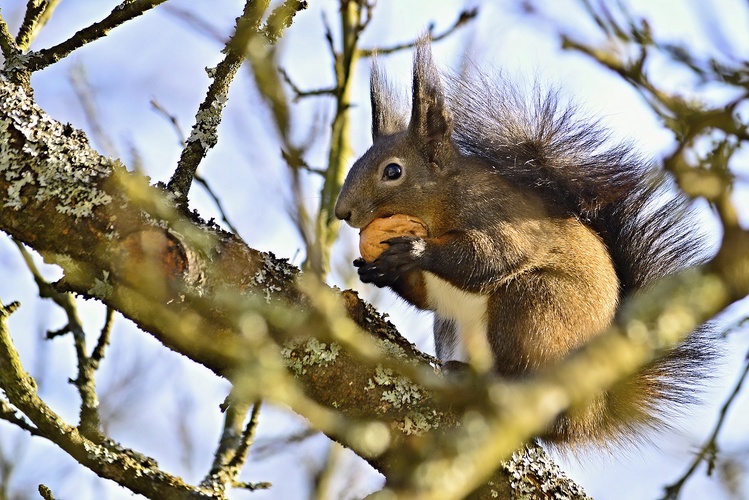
left=447, top=66, right=715, bottom=444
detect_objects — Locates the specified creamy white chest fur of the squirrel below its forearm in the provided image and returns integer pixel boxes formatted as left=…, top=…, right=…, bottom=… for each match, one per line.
left=424, top=272, right=493, bottom=370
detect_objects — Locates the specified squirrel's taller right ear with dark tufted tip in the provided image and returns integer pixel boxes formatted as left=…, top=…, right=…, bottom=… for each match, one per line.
left=409, top=36, right=453, bottom=161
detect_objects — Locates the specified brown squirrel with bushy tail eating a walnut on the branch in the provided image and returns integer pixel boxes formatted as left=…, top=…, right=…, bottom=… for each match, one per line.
left=335, top=39, right=713, bottom=447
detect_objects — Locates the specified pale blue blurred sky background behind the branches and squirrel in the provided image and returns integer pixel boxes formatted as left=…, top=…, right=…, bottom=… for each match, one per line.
left=0, top=0, right=749, bottom=500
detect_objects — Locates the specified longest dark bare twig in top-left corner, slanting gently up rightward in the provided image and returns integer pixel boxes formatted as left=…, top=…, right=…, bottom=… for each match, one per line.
left=26, top=0, right=166, bottom=72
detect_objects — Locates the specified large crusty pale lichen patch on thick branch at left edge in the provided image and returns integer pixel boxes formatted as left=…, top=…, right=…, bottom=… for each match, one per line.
left=0, top=77, right=112, bottom=219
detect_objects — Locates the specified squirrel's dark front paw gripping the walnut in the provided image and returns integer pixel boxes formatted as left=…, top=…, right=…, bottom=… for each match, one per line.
left=354, top=236, right=426, bottom=287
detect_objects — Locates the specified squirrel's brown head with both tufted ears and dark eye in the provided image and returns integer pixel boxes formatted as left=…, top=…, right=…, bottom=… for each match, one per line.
left=335, top=38, right=458, bottom=228
